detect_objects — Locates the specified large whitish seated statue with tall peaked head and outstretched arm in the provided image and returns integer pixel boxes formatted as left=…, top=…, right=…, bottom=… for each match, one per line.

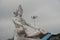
left=12, top=5, right=44, bottom=40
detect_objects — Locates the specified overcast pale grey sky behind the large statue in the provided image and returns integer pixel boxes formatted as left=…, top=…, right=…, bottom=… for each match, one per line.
left=0, top=0, right=60, bottom=40
